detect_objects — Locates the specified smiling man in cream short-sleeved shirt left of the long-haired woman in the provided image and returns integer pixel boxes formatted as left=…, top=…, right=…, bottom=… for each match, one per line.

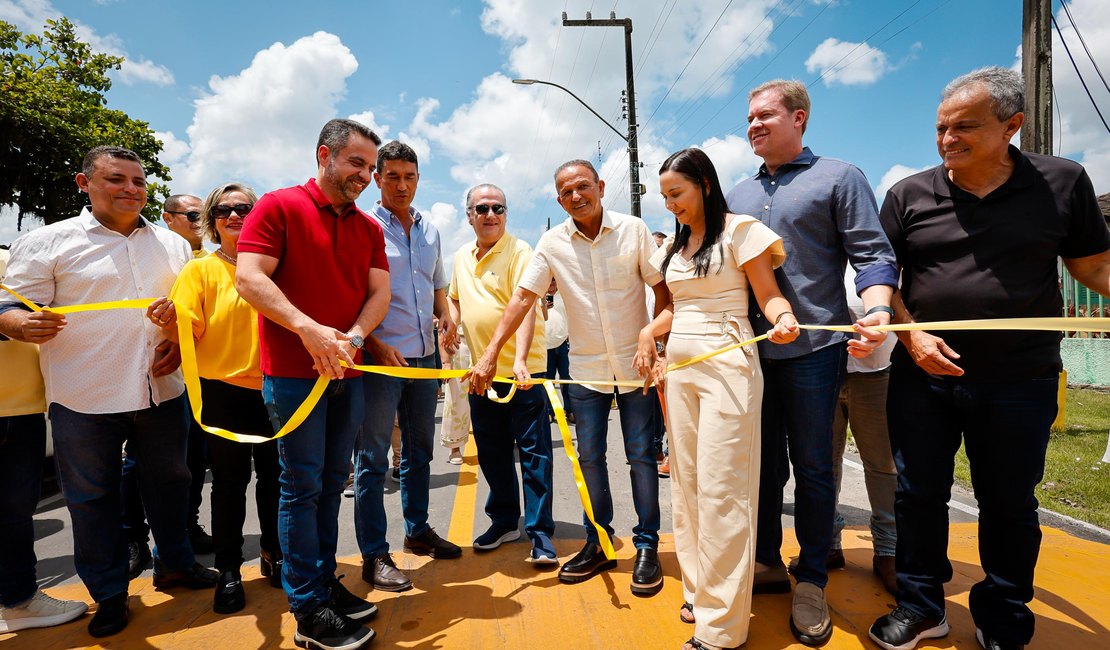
left=471, top=160, right=668, bottom=595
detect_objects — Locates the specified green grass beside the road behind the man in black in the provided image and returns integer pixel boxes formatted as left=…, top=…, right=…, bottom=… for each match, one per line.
left=956, top=388, right=1110, bottom=528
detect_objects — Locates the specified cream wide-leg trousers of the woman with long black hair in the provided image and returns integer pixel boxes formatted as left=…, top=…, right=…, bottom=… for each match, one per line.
left=666, top=334, right=763, bottom=648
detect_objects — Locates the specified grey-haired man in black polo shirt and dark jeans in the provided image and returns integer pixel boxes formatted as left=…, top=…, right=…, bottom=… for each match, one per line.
left=870, top=68, right=1110, bottom=649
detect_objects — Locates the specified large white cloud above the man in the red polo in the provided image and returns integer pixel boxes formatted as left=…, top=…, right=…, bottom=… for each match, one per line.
left=171, top=32, right=359, bottom=194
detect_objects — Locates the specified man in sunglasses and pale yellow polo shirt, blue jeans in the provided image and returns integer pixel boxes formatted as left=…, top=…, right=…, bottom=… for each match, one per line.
left=448, top=184, right=558, bottom=565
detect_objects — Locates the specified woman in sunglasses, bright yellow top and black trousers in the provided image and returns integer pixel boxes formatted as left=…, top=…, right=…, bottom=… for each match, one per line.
left=170, top=183, right=282, bottom=613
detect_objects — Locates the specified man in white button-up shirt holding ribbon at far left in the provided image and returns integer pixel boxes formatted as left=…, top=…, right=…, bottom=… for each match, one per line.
left=0, top=146, right=218, bottom=638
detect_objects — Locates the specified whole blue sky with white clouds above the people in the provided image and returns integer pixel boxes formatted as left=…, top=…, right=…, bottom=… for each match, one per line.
left=0, top=0, right=1110, bottom=258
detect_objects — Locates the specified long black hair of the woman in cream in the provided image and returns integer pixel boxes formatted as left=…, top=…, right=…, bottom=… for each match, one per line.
left=659, top=146, right=728, bottom=276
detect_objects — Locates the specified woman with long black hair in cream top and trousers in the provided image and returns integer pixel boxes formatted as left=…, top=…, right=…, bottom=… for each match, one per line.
left=636, top=149, right=798, bottom=650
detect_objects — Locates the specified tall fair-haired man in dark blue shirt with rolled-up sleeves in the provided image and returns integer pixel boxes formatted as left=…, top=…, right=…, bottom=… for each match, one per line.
left=727, top=80, right=898, bottom=644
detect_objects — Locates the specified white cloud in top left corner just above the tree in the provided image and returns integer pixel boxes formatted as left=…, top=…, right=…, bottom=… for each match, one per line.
left=0, top=0, right=173, bottom=85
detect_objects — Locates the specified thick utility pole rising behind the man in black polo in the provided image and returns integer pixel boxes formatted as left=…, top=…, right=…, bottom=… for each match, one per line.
left=1021, top=0, right=1052, bottom=154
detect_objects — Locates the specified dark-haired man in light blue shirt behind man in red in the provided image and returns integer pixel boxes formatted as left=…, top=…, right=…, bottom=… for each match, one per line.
left=355, top=141, right=462, bottom=591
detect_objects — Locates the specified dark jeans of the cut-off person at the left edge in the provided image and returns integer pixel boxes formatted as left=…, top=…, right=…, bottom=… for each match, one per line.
left=0, top=413, right=47, bottom=607
